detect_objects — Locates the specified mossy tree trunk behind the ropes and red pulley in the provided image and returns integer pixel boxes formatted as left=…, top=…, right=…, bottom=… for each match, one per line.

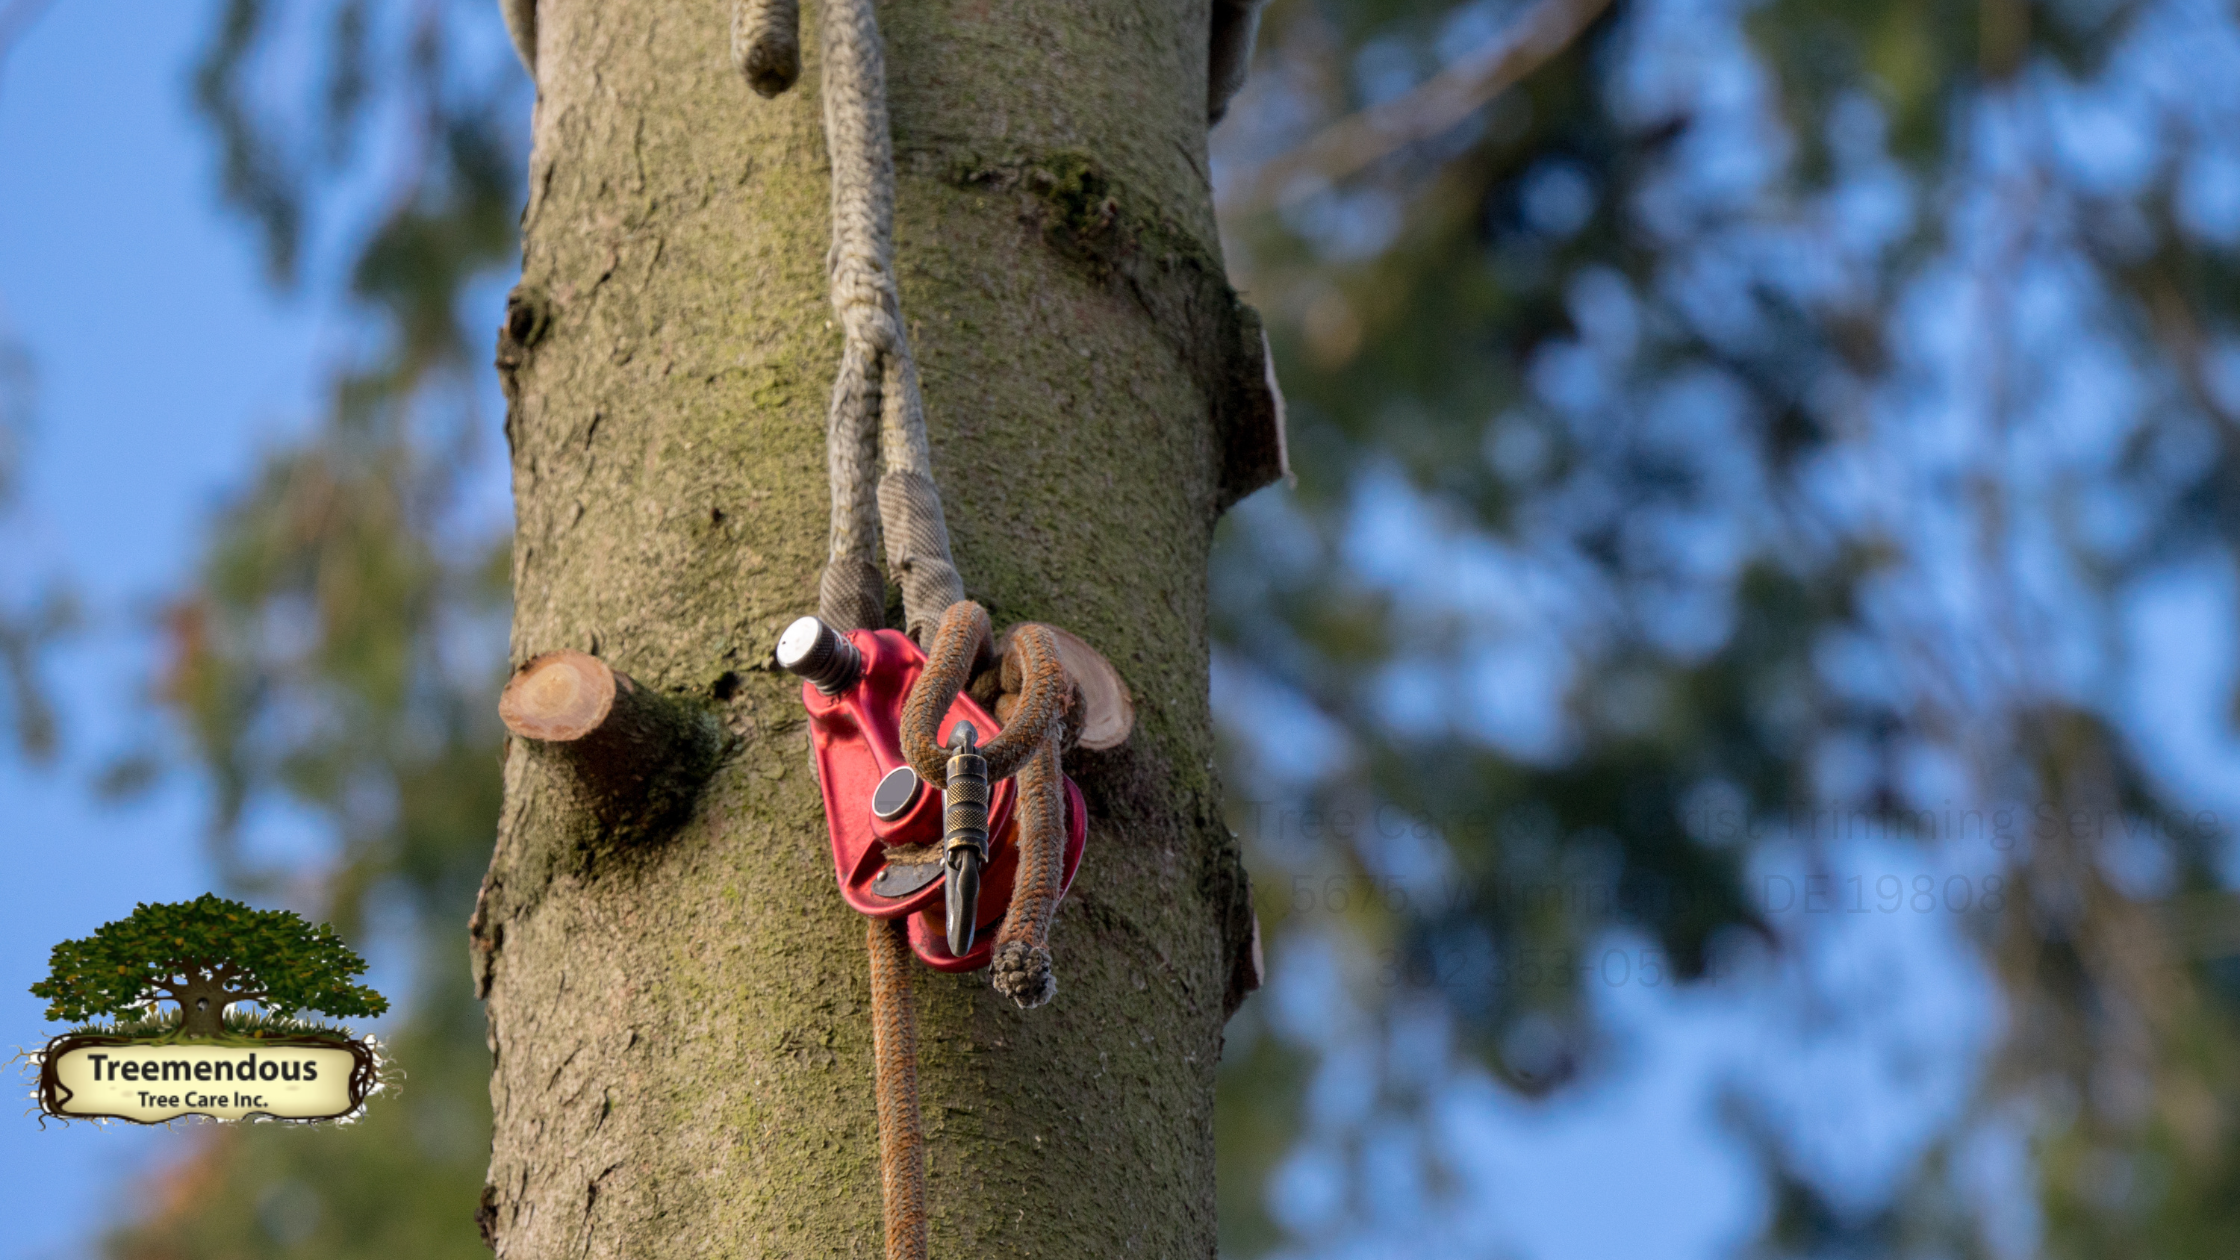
left=473, top=0, right=1277, bottom=1260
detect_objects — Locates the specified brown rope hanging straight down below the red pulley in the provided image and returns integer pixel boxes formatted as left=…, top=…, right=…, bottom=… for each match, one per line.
left=865, top=919, right=925, bottom=1260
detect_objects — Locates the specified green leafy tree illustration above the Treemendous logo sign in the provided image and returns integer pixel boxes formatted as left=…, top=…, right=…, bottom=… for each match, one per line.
left=31, top=892, right=390, bottom=1038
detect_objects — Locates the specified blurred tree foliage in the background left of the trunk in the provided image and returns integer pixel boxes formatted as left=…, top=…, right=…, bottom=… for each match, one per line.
left=108, top=0, right=529, bottom=1260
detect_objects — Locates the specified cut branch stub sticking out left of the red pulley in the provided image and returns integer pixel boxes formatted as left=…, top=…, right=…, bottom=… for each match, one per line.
left=497, top=650, right=724, bottom=843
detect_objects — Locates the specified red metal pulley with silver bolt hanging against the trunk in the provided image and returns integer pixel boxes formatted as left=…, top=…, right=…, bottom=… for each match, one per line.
left=777, top=617, right=1089, bottom=971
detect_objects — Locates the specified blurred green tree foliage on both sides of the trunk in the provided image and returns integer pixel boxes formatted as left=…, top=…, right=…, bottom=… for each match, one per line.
left=112, top=0, right=2240, bottom=1258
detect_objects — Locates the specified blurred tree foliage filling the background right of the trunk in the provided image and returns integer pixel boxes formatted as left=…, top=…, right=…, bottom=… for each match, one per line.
left=1214, top=0, right=2240, bottom=1256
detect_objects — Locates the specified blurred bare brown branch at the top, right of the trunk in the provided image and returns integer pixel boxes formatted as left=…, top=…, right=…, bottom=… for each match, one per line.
left=1219, top=0, right=1611, bottom=215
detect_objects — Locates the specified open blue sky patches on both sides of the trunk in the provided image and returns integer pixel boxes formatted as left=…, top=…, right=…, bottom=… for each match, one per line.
left=0, top=0, right=2240, bottom=1260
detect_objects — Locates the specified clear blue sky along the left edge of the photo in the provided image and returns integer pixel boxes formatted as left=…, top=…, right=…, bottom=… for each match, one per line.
left=0, top=0, right=336, bottom=1260
